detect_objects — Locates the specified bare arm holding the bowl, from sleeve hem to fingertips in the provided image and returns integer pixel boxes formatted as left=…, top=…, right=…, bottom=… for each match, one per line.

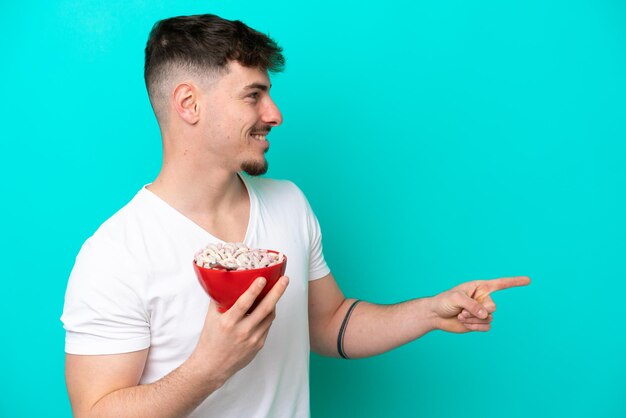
left=65, top=277, right=288, bottom=418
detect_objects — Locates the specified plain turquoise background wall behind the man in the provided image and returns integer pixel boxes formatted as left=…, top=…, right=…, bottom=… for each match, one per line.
left=0, top=0, right=626, bottom=418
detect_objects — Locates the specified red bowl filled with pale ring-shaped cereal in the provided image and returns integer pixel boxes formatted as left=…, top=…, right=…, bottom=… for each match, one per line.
left=193, top=243, right=287, bottom=313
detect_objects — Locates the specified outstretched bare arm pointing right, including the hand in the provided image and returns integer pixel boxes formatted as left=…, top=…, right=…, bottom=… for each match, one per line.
left=309, top=274, right=530, bottom=358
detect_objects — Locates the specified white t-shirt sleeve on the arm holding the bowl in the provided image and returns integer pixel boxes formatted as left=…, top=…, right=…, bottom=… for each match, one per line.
left=61, top=237, right=150, bottom=355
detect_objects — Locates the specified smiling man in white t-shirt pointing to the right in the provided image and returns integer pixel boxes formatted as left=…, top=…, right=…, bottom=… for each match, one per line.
left=62, top=15, right=530, bottom=417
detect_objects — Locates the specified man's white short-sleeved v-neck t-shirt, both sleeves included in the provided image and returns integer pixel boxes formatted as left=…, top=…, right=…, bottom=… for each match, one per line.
left=61, top=174, right=330, bottom=417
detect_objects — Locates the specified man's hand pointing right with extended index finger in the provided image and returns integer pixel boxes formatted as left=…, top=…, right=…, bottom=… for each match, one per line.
left=430, top=276, right=530, bottom=333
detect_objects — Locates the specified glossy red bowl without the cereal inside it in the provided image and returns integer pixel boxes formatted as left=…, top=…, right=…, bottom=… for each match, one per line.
left=192, top=250, right=287, bottom=313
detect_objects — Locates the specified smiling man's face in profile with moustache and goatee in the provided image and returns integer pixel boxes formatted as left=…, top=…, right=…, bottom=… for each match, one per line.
left=202, top=62, right=282, bottom=176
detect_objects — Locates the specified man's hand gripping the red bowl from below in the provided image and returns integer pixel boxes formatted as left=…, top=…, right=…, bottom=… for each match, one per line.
left=190, top=276, right=289, bottom=381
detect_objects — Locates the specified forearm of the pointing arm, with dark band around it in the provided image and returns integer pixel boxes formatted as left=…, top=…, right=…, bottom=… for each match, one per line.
left=333, top=298, right=436, bottom=358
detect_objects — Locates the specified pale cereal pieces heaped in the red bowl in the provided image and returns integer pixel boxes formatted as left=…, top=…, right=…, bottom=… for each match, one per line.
left=194, top=242, right=284, bottom=270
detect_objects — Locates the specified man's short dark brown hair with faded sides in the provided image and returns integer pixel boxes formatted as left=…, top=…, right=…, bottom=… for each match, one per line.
left=144, top=14, right=285, bottom=122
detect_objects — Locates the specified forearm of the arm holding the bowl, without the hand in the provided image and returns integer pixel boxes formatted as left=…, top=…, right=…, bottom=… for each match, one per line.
left=86, top=356, right=225, bottom=418
